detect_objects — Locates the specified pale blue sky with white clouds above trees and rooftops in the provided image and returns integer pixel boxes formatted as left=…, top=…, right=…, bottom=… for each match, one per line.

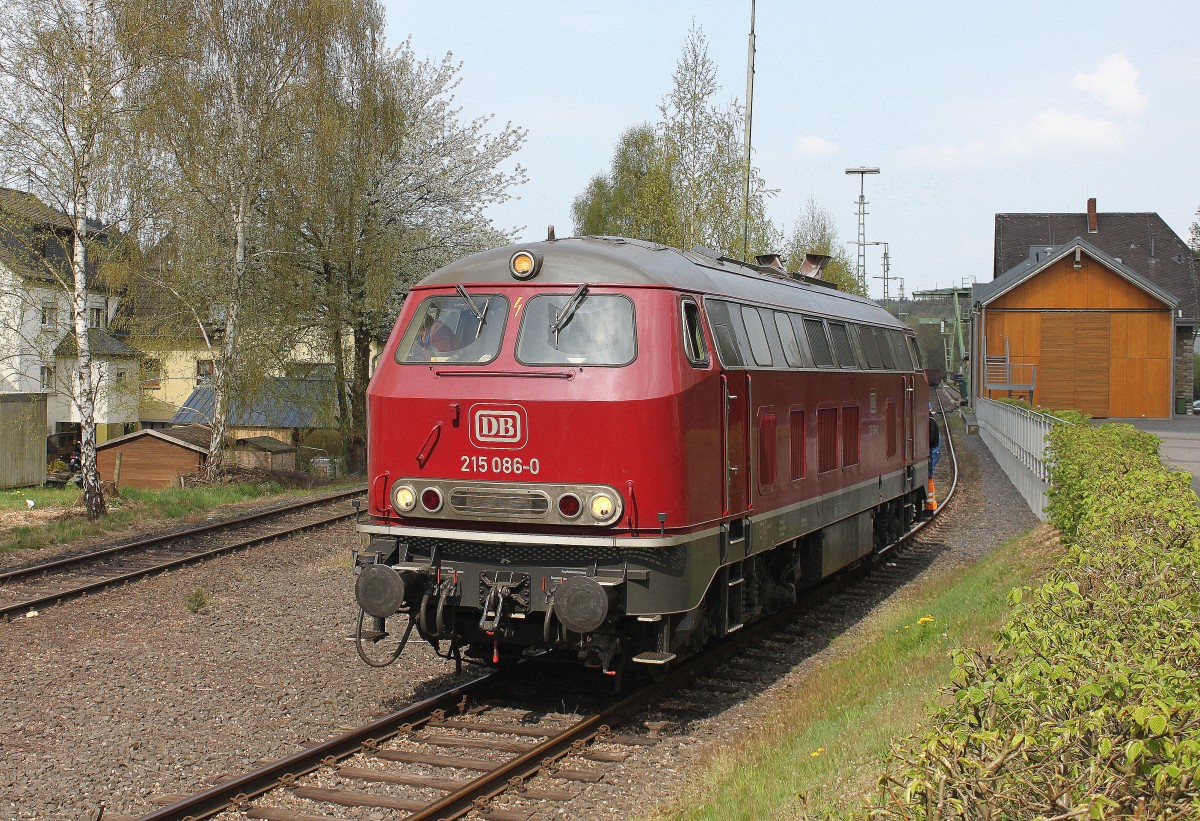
left=385, top=0, right=1200, bottom=298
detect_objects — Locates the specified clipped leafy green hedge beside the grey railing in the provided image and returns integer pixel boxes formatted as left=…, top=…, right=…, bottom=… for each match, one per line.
left=869, top=425, right=1200, bottom=820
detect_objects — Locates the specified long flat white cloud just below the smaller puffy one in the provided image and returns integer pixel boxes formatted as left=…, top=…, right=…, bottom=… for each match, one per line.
left=907, top=109, right=1124, bottom=168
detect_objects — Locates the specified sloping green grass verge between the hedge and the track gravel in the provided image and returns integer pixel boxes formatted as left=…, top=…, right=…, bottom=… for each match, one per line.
left=653, top=526, right=1057, bottom=821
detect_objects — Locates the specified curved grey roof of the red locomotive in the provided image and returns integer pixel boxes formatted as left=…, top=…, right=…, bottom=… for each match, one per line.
left=418, top=236, right=906, bottom=328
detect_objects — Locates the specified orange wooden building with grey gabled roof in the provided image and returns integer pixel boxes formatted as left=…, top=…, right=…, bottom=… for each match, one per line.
left=971, top=235, right=1176, bottom=418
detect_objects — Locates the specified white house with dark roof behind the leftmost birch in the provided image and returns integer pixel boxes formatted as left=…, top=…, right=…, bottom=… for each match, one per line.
left=0, top=188, right=142, bottom=442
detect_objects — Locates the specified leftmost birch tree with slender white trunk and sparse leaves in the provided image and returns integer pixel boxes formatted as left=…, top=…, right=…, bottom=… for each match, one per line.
left=0, top=0, right=147, bottom=519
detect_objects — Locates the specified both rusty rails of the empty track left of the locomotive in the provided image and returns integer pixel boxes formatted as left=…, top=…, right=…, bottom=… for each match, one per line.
left=0, top=489, right=365, bottom=622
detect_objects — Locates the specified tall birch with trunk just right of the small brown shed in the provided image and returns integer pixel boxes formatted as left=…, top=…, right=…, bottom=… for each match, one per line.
left=137, top=0, right=362, bottom=479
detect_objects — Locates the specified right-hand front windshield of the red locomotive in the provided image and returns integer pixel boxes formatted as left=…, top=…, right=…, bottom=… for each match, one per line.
left=517, top=287, right=637, bottom=365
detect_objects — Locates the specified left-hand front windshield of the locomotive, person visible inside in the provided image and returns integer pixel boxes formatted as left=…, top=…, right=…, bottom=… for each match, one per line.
left=396, top=293, right=509, bottom=364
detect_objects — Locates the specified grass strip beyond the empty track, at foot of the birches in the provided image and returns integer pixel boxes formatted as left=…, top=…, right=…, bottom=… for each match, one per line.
left=0, top=481, right=354, bottom=553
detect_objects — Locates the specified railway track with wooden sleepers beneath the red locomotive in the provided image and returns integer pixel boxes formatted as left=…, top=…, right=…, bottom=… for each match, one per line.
left=124, top=396, right=958, bottom=821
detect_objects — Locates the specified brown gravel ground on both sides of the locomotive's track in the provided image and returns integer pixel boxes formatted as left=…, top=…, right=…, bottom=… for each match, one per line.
left=0, top=417, right=1036, bottom=821
